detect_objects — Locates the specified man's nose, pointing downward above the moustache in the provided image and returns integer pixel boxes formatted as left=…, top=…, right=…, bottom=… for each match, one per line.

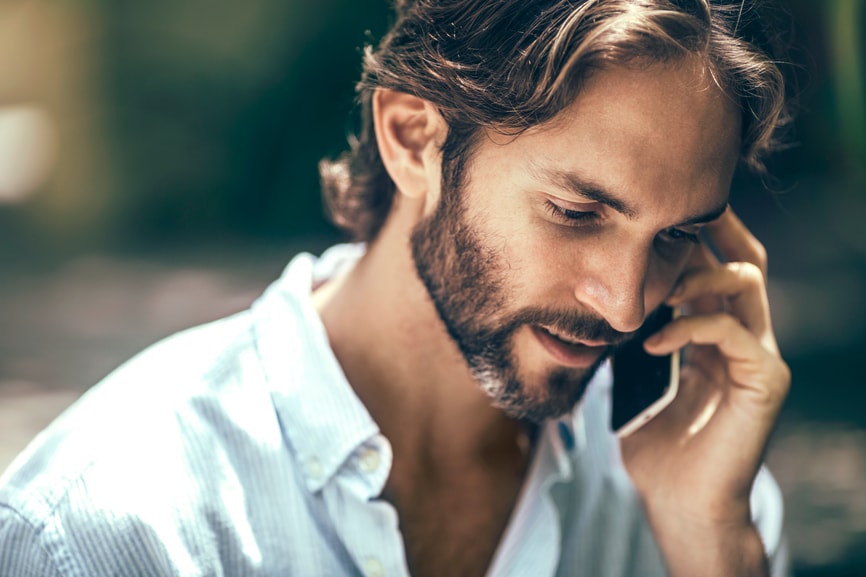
left=575, top=244, right=649, bottom=333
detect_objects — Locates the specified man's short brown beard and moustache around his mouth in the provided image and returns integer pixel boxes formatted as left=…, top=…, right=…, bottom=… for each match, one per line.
left=411, top=178, right=625, bottom=423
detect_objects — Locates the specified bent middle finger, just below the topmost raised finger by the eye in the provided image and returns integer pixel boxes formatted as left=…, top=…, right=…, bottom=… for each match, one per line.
left=666, top=262, right=775, bottom=341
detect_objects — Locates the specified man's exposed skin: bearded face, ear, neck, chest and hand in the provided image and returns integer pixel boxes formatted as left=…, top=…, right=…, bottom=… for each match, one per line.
left=314, top=59, right=789, bottom=576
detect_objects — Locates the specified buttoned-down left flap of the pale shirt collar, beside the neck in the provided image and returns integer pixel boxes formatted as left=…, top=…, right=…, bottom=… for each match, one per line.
left=246, top=245, right=379, bottom=492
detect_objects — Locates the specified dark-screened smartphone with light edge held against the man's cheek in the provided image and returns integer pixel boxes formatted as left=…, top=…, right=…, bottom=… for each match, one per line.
left=610, top=305, right=680, bottom=437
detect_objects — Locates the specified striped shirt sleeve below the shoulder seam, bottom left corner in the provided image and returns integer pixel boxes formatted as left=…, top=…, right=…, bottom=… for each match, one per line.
left=0, top=505, right=61, bottom=577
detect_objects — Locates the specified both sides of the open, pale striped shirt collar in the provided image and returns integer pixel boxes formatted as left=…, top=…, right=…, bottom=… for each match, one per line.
left=252, top=244, right=612, bottom=491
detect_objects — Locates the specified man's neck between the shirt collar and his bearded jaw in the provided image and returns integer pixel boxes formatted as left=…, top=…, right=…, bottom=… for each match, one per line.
left=314, top=198, right=526, bottom=468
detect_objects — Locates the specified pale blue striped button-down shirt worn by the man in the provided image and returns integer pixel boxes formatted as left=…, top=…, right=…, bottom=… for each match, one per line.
left=0, top=246, right=784, bottom=577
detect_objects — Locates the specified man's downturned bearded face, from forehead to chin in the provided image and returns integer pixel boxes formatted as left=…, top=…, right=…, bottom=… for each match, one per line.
left=412, top=60, right=740, bottom=421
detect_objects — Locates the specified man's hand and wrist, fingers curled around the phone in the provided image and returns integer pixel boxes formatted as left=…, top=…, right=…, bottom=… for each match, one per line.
left=613, top=209, right=791, bottom=575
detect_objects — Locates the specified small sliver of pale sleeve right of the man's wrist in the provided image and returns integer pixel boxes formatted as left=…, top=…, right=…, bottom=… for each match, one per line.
left=751, top=466, right=791, bottom=577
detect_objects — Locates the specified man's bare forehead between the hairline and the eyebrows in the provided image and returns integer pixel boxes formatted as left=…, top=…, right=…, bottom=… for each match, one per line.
left=479, top=58, right=741, bottom=216
